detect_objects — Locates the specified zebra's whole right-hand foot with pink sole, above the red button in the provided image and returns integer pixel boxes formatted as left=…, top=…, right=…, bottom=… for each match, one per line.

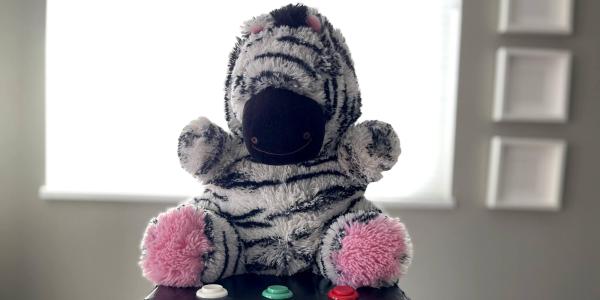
left=317, top=211, right=412, bottom=288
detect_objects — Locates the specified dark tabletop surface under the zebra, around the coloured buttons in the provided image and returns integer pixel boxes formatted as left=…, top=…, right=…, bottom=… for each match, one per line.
left=145, top=272, right=409, bottom=300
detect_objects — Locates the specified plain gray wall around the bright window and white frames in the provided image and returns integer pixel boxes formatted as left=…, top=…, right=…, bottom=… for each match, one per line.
left=0, top=0, right=600, bottom=300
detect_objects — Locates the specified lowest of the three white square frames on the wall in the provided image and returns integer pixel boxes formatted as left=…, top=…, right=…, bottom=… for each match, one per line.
left=487, top=136, right=566, bottom=211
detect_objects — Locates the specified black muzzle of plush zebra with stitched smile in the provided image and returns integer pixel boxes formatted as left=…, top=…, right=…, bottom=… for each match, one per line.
left=242, top=87, right=325, bottom=165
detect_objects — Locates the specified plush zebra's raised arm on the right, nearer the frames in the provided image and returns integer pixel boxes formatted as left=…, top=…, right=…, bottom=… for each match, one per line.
left=338, top=121, right=400, bottom=184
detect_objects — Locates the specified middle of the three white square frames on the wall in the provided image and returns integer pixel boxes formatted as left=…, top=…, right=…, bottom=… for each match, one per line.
left=493, top=47, right=571, bottom=122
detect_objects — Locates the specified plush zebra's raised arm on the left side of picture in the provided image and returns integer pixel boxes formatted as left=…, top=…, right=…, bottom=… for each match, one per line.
left=177, top=117, right=243, bottom=182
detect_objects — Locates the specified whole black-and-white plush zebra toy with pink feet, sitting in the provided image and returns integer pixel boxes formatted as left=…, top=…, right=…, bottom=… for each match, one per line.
left=140, top=5, right=412, bottom=287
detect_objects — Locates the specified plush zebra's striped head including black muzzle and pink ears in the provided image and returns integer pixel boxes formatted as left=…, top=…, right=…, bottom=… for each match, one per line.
left=225, top=4, right=360, bottom=165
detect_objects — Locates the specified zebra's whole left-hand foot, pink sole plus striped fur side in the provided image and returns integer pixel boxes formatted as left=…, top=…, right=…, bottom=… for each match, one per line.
left=140, top=205, right=243, bottom=287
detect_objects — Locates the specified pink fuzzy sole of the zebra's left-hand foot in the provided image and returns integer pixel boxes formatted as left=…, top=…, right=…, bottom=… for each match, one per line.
left=141, top=207, right=213, bottom=286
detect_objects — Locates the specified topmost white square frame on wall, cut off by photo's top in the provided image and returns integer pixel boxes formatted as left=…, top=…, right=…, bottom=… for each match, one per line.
left=498, top=0, right=574, bottom=34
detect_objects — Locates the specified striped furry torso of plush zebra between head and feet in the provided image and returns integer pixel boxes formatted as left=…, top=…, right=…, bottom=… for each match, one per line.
left=188, top=157, right=375, bottom=275
